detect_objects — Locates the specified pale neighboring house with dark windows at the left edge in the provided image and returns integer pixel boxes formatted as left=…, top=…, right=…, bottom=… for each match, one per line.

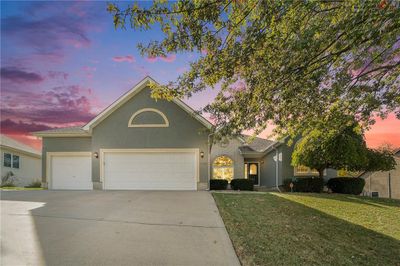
left=0, top=135, right=42, bottom=186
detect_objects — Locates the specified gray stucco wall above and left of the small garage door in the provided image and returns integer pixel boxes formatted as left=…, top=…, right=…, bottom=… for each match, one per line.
left=42, top=137, right=92, bottom=183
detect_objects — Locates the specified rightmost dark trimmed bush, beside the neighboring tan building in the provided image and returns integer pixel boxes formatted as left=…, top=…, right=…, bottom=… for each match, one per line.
left=328, top=177, right=365, bottom=195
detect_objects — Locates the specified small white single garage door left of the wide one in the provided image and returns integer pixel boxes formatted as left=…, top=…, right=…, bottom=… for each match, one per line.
left=50, top=154, right=93, bottom=190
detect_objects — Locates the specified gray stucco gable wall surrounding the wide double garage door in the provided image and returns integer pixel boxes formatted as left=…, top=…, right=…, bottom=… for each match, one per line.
left=92, top=88, right=208, bottom=186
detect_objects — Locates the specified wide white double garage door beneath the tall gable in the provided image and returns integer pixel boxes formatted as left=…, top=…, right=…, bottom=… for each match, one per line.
left=103, top=150, right=198, bottom=190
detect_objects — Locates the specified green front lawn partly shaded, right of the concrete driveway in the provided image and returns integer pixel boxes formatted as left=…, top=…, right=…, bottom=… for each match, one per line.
left=213, top=193, right=400, bottom=265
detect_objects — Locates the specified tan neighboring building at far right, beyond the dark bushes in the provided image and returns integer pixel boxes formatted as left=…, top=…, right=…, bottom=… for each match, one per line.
left=360, top=150, right=400, bottom=199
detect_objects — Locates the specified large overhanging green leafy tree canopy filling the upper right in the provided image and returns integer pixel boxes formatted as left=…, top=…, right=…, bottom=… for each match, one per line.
left=108, top=0, right=400, bottom=138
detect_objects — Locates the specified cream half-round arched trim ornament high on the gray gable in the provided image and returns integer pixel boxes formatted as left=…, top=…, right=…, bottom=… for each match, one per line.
left=128, top=108, right=169, bottom=127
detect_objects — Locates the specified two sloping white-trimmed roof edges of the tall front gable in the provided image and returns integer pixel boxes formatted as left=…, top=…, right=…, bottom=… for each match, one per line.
left=83, top=76, right=212, bottom=131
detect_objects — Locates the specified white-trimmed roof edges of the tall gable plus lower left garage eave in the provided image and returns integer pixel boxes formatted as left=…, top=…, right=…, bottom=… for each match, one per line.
left=33, top=76, right=213, bottom=137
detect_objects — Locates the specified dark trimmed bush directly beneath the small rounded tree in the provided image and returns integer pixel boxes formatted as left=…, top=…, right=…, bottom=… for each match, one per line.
left=283, top=176, right=324, bottom=193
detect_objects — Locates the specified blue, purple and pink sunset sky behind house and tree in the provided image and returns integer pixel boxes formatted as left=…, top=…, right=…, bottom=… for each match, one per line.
left=0, top=1, right=400, bottom=149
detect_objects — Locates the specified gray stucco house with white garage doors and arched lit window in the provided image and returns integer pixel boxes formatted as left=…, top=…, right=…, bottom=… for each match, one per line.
left=34, top=77, right=336, bottom=190
